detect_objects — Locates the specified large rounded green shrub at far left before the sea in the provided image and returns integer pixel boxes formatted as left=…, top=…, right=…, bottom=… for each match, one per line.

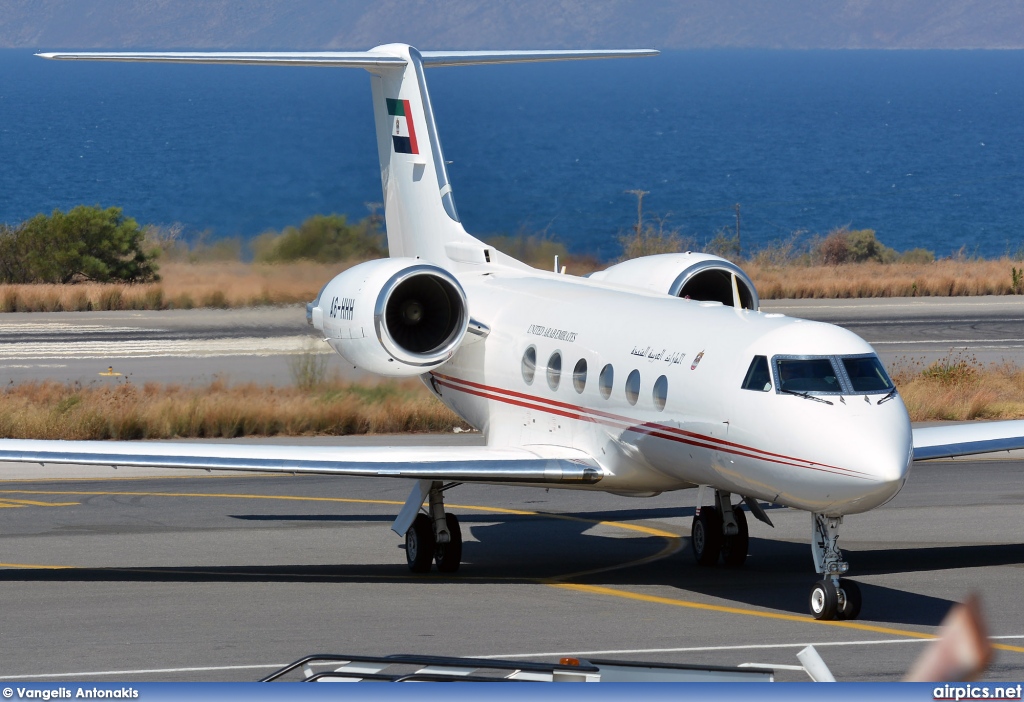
left=0, top=206, right=159, bottom=283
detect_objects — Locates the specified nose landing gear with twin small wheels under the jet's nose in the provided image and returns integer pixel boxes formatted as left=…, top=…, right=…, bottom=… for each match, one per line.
left=810, top=514, right=861, bottom=620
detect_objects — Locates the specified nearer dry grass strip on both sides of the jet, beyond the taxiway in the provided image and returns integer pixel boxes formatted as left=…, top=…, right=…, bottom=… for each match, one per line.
left=6, top=355, right=1024, bottom=439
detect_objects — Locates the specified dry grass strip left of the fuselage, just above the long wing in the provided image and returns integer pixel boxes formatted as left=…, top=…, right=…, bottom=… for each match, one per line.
left=0, top=381, right=465, bottom=439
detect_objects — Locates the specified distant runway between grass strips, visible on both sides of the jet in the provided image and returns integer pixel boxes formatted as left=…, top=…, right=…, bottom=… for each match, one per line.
left=0, top=296, right=1024, bottom=385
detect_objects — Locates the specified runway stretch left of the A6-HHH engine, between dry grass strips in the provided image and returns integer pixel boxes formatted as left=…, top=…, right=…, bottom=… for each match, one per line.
left=0, top=305, right=370, bottom=386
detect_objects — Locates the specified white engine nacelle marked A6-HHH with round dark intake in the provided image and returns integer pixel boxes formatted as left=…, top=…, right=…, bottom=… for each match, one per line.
left=306, top=258, right=469, bottom=378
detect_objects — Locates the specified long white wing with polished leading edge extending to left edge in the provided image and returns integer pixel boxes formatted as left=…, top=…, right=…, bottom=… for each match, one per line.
left=0, top=439, right=602, bottom=484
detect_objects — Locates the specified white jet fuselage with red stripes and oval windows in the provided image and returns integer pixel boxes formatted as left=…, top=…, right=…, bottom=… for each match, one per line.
left=425, top=271, right=912, bottom=515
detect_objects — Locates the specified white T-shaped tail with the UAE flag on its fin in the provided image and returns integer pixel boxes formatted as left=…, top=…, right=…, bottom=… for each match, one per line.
left=39, top=44, right=657, bottom=265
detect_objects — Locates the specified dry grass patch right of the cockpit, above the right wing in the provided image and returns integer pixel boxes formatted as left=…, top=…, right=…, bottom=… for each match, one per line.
left=892, top=354, right=1024, bottom=422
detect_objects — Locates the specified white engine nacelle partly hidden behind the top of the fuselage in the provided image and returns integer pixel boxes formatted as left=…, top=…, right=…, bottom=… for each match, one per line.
left=590, top=252, right=760, bottom=310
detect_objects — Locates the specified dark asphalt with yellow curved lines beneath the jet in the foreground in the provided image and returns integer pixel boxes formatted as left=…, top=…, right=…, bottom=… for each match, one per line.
left=0, top=435, right=1024, bottom=682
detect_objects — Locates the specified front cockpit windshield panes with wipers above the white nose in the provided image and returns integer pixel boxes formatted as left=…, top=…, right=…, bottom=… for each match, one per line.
left=770, top=354, right=893, bottom=395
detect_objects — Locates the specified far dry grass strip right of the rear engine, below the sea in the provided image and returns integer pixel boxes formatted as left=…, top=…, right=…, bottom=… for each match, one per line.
left=743, top=258, right=1021, bottom=300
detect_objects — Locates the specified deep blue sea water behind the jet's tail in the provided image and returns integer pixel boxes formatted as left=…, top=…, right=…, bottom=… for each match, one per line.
left=0, top=50, right=1024, bottom=259
